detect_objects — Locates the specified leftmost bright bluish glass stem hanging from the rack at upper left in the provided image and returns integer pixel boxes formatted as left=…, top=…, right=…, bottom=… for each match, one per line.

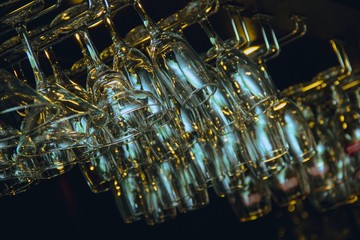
left=15, top=22, right=47, bottom=89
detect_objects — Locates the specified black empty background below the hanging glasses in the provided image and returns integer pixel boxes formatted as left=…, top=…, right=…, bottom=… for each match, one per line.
left=0, top=169, right=360, bottom=240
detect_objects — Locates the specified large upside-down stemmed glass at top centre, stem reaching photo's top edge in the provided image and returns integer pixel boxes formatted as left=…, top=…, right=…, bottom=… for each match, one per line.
left=133, top=0, right=216, bottom=108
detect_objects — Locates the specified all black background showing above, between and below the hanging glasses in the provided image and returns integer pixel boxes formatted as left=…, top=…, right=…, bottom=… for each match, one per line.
left=0, top=0, right=360, bottom=240
